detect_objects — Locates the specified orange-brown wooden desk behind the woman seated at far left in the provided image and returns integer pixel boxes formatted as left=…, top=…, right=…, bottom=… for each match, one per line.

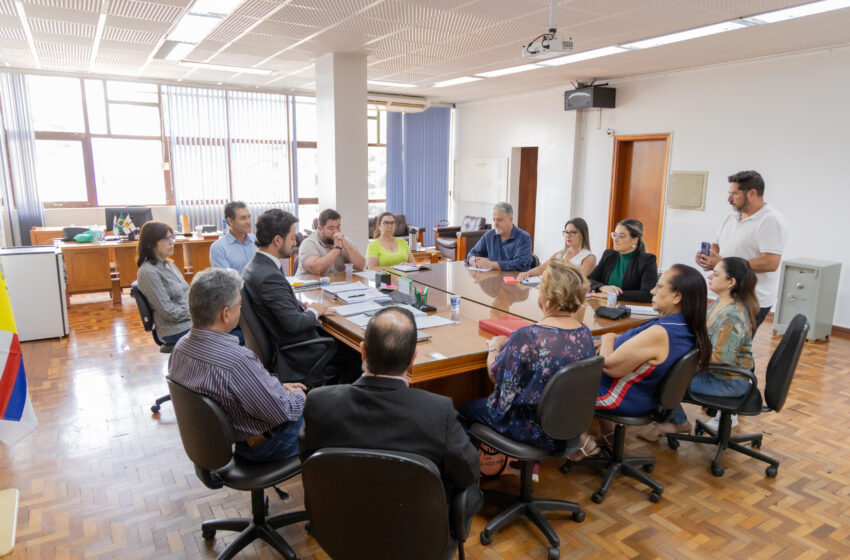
left=58, top=237, right=215, bottom=303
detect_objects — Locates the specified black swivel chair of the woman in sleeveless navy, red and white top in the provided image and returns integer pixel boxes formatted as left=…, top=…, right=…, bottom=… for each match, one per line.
left=561, top=349, right=699, bottom=504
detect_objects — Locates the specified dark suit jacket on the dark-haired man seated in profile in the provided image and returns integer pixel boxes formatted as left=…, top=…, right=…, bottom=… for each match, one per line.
left=242, top=253, right=325, bottom=380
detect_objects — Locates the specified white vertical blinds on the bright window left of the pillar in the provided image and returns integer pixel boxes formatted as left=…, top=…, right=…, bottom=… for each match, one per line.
left=162, top=86, right=296, bottom=230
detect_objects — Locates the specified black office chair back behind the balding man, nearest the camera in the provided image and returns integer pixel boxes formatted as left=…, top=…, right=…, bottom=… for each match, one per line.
left=301, top=447, right=469, bottom=560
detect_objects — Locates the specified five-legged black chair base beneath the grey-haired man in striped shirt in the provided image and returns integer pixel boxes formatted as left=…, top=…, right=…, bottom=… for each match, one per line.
left=201, top=489, right=307, bottom=560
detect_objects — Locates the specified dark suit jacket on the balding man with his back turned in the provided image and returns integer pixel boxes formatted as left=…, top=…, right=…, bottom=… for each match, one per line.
left=300, top=376, right=480, bottom=504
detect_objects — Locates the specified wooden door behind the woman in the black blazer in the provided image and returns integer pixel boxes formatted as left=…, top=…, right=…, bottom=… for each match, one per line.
left=606, top=134, right=670, bottom=256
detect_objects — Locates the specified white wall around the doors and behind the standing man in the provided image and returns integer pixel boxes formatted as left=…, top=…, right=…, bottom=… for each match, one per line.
left=456, top=47, right=850, bottom=327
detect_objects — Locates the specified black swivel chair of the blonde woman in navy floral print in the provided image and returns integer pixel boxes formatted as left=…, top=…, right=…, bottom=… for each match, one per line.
left=470, top=356, right=603, bottom=560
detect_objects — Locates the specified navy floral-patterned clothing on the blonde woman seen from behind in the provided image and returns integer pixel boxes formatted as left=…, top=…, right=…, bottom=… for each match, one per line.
left=480, top=325, right=595, bottom=453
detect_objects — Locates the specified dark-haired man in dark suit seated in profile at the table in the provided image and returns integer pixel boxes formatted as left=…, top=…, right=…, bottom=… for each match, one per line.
left=242, top=208, right=362, bottom=387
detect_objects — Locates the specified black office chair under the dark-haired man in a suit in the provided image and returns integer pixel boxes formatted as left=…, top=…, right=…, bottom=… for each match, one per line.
left=239, top=286, right=337, bottom=387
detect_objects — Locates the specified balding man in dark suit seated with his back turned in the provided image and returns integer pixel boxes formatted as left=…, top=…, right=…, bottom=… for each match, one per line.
left=301, top=307, right=483, bottom=528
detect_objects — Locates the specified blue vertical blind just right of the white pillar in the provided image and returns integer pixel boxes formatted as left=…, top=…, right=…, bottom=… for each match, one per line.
left=387, top=107, right=451, bottom=245
